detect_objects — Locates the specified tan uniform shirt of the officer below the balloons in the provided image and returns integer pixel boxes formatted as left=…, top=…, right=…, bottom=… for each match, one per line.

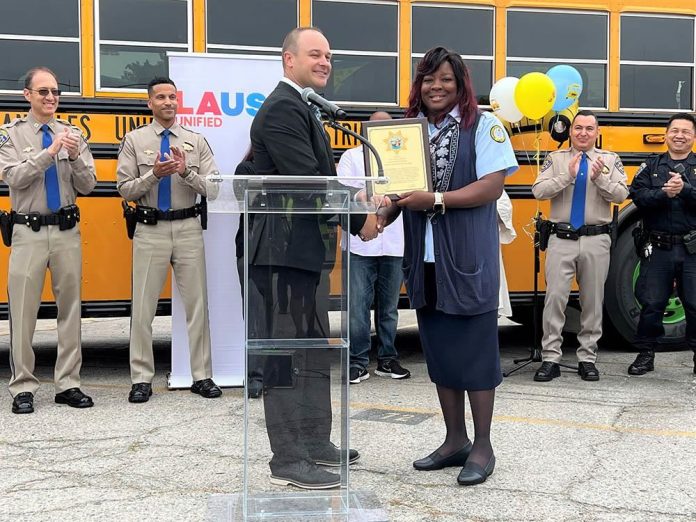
left=532, top=147, right=628, bottom=225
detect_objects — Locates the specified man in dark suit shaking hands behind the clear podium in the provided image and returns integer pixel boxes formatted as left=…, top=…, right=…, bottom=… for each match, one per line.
left=247, top=28, right=381, bottom=489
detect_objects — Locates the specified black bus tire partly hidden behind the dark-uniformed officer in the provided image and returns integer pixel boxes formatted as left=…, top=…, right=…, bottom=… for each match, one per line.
left=604, top=223, right=686, bottom=349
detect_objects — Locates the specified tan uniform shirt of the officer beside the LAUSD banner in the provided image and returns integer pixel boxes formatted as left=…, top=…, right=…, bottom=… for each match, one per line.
left=116, top=120, right=219, bottom=205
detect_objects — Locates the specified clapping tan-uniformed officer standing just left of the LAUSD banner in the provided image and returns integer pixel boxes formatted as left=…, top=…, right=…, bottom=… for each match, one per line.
left=117, top=78, right=222, bottom=402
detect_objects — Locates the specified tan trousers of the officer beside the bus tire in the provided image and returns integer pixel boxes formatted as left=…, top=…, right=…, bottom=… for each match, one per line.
left=541, top=234, right=611, bottom=363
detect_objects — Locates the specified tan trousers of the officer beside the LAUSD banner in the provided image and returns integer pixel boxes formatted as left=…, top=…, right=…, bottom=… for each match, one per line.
left=130, top=218, right=213, bottom=383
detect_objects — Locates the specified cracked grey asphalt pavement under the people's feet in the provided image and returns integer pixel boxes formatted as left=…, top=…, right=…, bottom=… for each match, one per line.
left=0, top=312, right=696, bottom=522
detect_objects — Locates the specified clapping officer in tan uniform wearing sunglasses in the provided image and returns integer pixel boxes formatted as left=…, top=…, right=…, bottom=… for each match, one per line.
left=0, top=67, right=97, bottom=413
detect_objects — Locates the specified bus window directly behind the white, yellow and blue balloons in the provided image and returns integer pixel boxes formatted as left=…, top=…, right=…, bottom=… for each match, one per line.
left=507, top=9, right=609, bottom=108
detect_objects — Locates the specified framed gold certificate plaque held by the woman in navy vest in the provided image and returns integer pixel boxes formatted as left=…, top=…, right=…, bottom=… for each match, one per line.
left=362, top=118, right=432, bottom=196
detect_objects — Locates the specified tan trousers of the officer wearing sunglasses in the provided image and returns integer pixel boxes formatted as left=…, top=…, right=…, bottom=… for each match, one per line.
left=7, top=224, right=82, bottom=397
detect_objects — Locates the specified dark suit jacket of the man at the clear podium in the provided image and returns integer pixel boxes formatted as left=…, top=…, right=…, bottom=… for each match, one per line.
left=249, top=82, right=365, bottom=272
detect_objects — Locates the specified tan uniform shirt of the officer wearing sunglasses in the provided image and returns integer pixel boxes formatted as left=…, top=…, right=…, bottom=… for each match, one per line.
left=0, top=112, right=97, bottom=214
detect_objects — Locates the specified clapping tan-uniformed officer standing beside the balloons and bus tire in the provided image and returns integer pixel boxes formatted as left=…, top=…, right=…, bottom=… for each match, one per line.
left=532, top=110, right=628, bottom=382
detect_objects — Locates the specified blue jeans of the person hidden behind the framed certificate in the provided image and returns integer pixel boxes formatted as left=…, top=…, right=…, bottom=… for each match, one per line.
left=350, top=254, right=404, bottom=369
